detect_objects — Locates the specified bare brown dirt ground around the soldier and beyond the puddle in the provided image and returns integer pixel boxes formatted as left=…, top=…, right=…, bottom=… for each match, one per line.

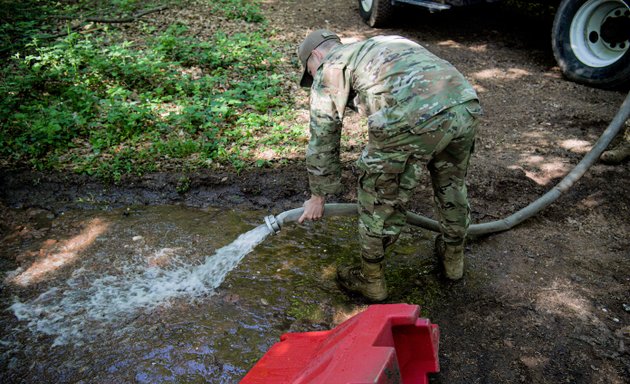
left=0, top=0, right=630, bottom=383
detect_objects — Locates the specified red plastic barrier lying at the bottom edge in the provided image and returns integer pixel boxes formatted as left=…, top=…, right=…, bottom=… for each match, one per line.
left=241, top=304, right=440, bottom=384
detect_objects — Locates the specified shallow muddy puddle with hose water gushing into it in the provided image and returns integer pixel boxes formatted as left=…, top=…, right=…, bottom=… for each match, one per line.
left=0, top=206, right=431, bottom=383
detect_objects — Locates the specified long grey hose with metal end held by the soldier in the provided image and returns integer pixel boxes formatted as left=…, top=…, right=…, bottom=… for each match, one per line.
left=265, top=92, right=630, bottom=236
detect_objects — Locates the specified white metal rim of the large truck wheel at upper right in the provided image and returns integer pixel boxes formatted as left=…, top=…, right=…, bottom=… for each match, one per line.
left=569, top=0, right=630, bottom=68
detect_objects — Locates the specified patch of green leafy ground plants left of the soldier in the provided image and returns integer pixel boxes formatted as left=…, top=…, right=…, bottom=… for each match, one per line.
left=0, top=0, right=306, bottom=181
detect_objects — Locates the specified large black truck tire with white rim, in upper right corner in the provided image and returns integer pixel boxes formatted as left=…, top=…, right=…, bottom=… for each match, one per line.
left=551, top=0, right=630, bottom=89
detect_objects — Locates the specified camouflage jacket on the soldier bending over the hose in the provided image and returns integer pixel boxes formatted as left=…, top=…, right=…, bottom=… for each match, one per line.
left=306, top=36, right=477, bottom=195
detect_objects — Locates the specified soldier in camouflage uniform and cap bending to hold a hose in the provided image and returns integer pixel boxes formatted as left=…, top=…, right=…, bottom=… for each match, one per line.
left=298, top=30, right=481, bottom=301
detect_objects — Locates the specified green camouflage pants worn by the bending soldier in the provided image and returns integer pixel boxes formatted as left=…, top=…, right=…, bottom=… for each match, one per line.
left=357, top=100, right=481, bottom=262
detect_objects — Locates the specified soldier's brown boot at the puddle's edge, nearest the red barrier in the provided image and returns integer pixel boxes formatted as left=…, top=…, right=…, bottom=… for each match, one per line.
left=337, top=260, right=387, bottom=301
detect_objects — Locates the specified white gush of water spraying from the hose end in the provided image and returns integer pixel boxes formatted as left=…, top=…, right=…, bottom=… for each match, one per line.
left=11, top=225, right=270, bottom=345
